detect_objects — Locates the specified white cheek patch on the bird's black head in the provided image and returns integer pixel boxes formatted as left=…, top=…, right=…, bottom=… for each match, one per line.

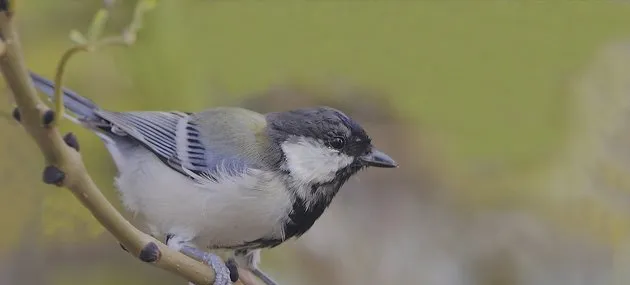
left=282, top=138, right=354, bottom=183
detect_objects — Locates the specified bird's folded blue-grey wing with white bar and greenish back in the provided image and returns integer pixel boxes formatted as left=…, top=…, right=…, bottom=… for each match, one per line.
left=96, top=108, right=265, bottom=183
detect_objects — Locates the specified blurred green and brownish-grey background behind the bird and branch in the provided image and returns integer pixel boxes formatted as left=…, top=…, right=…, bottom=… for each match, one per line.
left=0, top=0, right=630, bottom=285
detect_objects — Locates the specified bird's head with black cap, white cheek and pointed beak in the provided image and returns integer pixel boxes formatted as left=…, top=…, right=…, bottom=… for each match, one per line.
left=266, top=107, right=397, bottom=186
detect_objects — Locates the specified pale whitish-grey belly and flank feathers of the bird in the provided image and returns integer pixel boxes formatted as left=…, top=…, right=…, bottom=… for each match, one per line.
left=111, top=145, right=292, bottom=247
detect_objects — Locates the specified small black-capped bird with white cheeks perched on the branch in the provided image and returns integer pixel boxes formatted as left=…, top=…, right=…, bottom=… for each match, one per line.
left=29, top=71, right=398, bottom=285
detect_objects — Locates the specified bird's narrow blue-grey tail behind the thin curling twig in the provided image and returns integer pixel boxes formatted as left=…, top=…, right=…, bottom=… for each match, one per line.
left=30, top=72, right=98, bottom=120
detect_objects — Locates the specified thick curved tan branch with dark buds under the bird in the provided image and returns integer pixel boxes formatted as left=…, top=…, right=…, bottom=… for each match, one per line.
left=0, top=0, right=244, bottom=285
